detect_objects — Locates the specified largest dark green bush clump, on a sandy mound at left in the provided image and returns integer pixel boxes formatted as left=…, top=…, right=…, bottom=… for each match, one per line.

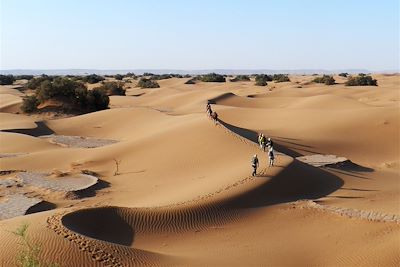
left=21, top=77, right=110, bottom=113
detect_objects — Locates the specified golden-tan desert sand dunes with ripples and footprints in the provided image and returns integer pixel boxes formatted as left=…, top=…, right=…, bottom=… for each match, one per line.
left=0, top=74, right=400, bottom=266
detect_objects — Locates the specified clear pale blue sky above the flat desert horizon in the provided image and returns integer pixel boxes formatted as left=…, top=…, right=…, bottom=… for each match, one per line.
left=0, top=0, right=400, bottom=70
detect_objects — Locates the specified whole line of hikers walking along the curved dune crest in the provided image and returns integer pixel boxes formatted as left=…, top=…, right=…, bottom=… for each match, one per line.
left=206, top=102, right=275, bottom=176
